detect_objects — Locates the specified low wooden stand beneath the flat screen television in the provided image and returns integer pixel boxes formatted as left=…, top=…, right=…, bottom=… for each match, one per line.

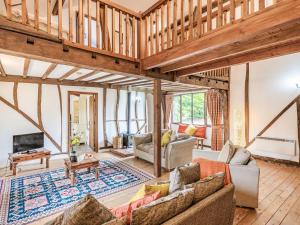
left=8, top=148, right=51, bottom=175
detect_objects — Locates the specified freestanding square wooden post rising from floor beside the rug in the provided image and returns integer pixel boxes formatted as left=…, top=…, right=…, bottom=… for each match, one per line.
left=153, top=79, right=161, bottom=177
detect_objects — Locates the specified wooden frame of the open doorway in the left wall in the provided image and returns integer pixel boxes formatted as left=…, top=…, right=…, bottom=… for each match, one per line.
left=67, top=91, right=99, bottom=152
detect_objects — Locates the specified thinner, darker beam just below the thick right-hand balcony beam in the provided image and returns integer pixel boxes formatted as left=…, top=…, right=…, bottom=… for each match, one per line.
left=176, top=37, right=300, bottom=74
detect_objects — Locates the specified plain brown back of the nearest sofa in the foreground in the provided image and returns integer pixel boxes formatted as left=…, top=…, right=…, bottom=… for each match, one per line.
left=163, top=184, right=235, bottom=225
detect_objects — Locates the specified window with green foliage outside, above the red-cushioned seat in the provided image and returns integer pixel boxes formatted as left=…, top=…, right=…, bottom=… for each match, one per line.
left=172, top=92, right=206, bottom=125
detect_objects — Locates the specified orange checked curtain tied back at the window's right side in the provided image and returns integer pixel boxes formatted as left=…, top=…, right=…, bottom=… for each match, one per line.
left=205, top=89, right=224, bottom=151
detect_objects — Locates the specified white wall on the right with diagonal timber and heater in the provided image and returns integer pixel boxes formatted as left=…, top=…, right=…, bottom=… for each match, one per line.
left=230, top=53, right=300, bottom=161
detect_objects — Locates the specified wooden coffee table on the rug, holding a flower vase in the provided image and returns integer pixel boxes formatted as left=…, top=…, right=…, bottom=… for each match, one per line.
left=65, top=158, right=99, bottom=185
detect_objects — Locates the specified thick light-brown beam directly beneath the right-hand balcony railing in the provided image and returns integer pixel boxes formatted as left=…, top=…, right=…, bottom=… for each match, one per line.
left=142, top=0, right=300, bottom=70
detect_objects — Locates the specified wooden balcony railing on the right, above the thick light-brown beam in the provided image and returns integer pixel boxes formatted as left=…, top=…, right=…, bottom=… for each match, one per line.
left=141, top=0, right=278, bottom=57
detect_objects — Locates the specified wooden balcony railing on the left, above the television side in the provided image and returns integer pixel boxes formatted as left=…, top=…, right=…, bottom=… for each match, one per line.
left=0, top=0, right=141, bottom=61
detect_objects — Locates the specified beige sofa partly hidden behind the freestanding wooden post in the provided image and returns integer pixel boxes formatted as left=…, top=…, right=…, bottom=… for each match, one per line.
left=133, top=133, right=196, bottom=170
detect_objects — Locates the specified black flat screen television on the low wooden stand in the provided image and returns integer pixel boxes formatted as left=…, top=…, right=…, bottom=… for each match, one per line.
left=13, top=132, right=44, bottom=153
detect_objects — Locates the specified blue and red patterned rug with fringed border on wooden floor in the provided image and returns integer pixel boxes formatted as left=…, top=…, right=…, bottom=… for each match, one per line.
left=0, top=159, right=153, bottom=225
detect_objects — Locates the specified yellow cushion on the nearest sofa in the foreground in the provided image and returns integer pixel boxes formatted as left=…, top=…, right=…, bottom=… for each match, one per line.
left=130, top=184, right=169, bottom=202
